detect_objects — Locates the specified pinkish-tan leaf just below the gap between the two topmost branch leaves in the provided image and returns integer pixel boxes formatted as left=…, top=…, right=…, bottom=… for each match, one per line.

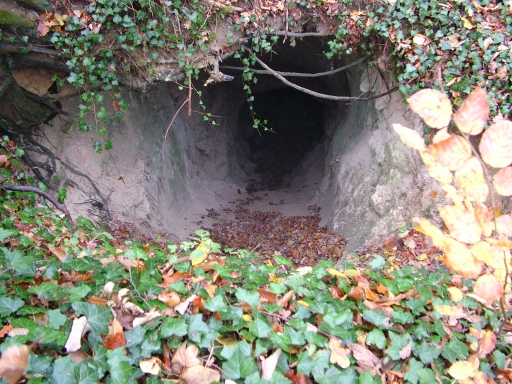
left=428, top=135, right=471, bottom=171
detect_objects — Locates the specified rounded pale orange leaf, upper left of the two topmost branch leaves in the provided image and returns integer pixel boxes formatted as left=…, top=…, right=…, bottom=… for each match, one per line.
left=407, top=89, right=452, bottom=129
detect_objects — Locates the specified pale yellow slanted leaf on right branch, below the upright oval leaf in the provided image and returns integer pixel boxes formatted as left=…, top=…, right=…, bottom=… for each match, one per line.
left=439, top=205, right=482, bottom=244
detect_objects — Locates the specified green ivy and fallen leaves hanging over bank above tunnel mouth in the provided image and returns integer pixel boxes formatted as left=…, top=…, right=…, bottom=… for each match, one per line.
left=34, top=0, right=512, bottom=145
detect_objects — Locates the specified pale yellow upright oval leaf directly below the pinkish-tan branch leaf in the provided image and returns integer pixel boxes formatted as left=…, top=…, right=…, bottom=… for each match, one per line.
left=455, top=156, right=489, bottom=203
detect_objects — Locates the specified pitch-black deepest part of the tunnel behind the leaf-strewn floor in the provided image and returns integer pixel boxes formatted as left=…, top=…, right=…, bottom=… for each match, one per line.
left=239, top=88, right=324, bottom=192
